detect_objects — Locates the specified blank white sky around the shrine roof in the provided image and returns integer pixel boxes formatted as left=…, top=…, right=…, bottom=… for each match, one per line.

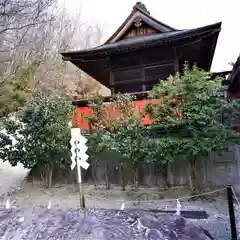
left=59, top=0, right=240, bottom=71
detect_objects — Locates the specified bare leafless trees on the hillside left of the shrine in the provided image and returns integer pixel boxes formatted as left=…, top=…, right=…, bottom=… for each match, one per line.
left=0, top=0, right=109, bottom=117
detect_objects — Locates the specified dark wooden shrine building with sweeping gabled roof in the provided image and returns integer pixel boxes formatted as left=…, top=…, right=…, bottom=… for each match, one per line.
left=61, top=2, right=227, bottom=130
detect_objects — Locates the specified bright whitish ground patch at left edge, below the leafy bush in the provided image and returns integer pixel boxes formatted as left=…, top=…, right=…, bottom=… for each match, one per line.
left=0, top=160, right=29, bottom=196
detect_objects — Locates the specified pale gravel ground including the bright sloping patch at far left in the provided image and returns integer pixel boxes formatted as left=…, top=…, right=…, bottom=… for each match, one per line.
left=0, top=161, right=236, bottom=240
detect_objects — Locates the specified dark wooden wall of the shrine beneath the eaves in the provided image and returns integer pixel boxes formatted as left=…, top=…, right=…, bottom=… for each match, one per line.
left=110, top=47, right=175, bottom=94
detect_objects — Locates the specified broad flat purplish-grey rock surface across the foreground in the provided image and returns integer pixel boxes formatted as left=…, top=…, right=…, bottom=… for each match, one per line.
left=0, top=208, right=212, bottom=240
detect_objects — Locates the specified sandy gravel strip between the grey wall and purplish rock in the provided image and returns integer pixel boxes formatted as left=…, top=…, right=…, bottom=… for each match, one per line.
left=0, top=183, right=237, bottom=240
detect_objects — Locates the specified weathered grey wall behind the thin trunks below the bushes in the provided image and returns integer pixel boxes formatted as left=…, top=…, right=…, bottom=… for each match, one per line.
left=55, top=145, right=240, bottom=195
